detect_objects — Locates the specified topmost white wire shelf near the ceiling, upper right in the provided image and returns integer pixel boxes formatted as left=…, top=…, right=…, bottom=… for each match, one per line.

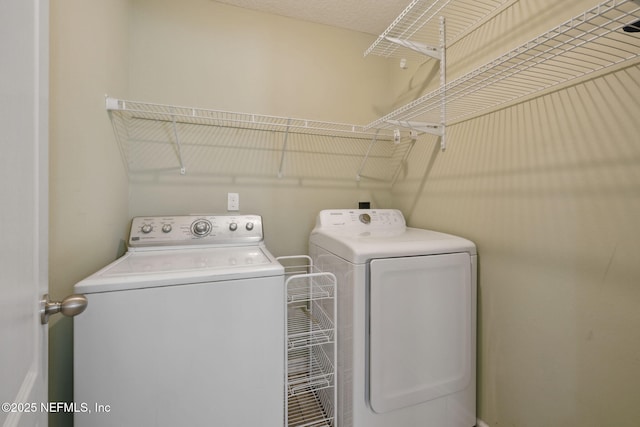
left=364, top=0, right=514, bottom=58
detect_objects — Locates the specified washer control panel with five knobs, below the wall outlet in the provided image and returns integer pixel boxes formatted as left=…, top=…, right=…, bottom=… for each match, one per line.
left=129, top=214, right=264, bottom=249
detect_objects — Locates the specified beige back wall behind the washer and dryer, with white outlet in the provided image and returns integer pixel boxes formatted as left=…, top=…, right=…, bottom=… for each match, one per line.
left=125, top=0, right=391, bottom=255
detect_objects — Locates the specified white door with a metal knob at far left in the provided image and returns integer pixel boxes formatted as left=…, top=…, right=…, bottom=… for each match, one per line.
left=0, top=0, right=49, bottom=427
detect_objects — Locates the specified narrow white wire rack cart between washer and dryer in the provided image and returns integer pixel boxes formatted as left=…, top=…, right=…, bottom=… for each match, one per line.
left=278, top=255, right=337, bottom=427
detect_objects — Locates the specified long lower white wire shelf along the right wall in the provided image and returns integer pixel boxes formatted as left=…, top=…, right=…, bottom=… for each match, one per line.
left=365, top=0, right=640, bottom=129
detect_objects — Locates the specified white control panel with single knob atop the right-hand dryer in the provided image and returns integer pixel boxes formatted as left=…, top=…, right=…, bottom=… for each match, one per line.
left=316, top=209, right=406, bottom=234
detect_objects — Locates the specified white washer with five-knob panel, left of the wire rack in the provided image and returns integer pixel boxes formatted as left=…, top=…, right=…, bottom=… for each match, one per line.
left=74, top=215, right=285, bottom=427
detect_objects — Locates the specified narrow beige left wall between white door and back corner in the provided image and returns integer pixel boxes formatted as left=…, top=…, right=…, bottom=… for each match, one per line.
left=49, top=0, right=129, bottom=426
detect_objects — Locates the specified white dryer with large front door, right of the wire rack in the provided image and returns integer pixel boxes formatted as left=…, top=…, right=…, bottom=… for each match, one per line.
left=309, top=209, right=477, bottom=427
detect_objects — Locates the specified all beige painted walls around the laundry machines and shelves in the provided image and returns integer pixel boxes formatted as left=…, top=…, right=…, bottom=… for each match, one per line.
left=50, top=0, right=640, bottom=427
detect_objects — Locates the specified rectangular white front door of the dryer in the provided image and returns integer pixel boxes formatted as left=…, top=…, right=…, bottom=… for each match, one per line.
left=368, top=253, right=473, bottom=413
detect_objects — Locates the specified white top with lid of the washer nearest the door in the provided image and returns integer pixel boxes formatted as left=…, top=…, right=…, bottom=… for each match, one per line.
left=74, top=246, right=284, bottom=293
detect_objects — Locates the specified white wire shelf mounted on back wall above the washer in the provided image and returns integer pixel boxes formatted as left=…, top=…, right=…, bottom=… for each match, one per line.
left=106, top=97, right=399, bottom=181
